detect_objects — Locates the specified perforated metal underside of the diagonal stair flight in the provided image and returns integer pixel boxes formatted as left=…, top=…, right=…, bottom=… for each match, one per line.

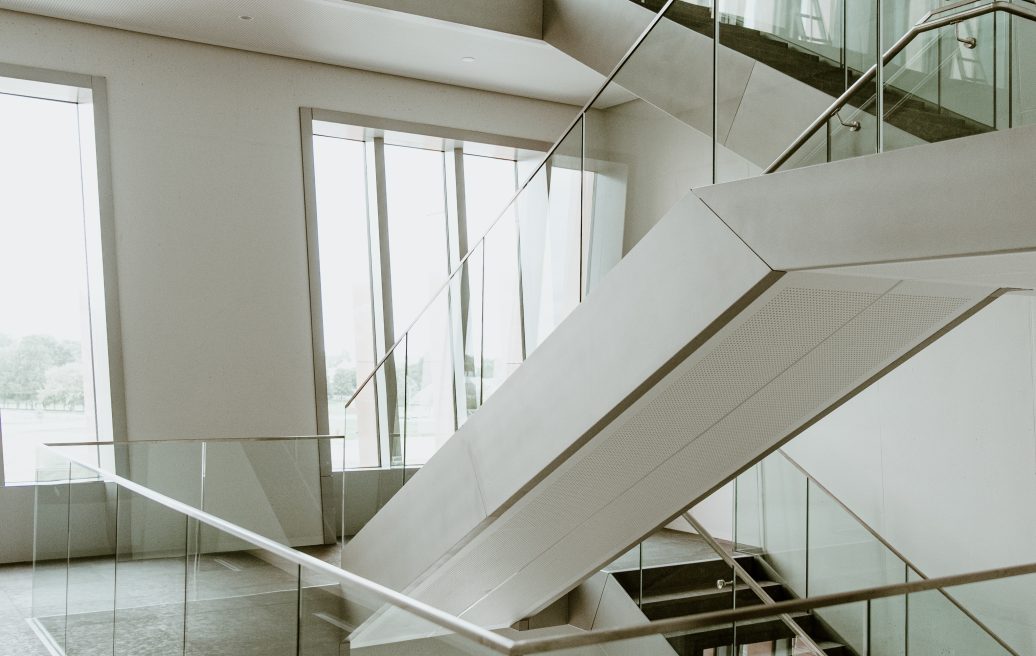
left=401, top=274, right=989, bottom=624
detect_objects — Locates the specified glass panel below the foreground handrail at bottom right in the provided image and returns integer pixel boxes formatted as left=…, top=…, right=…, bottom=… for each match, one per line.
left=519, top=566, right=1036, bottom=656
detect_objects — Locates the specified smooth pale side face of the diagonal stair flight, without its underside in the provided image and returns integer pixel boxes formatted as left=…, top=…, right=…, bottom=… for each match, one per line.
left=342, top=191, right=779, bottom=596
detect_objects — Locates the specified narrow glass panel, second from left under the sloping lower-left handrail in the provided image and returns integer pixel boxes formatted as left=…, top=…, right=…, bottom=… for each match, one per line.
left=64, top=462, right=115, bottom=656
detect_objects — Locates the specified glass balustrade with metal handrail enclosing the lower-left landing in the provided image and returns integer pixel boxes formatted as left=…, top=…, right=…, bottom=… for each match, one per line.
left=32, top=438, right=509, bottom=656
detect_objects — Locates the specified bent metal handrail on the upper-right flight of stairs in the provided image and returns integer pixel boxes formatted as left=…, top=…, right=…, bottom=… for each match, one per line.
left=762, top=0, right=1036, bottom=174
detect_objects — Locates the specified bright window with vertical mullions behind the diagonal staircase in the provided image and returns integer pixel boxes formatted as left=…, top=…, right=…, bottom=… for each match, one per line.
left=304, top=110, right=522, bottom=468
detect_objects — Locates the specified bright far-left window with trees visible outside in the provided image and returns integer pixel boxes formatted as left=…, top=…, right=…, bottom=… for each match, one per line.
left=0, top=67, right=115, bottom=483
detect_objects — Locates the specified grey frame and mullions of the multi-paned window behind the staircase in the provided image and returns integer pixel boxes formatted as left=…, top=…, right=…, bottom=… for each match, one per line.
left=299, top=107, right=551, bottom=468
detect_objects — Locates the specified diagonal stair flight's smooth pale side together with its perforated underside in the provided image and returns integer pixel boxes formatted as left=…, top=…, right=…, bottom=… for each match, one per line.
left=343, top=183, right=994, bottom=639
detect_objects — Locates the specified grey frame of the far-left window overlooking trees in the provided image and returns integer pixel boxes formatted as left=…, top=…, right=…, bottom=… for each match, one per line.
left=0, top=62, right=128, bottom=487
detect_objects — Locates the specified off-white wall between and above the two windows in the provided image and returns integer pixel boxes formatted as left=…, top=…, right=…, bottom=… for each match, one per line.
left=0, top=10, right=576, bottom=561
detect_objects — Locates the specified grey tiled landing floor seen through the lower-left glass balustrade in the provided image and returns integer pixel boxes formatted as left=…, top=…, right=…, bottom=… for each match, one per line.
left=0, top=547, right=352, bottom=656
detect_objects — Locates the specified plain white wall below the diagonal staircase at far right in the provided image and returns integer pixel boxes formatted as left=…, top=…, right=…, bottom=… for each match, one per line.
left=785, top=295, right=1036, bottom=654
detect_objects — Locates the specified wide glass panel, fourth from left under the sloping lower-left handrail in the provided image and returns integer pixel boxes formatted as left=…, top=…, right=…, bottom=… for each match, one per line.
left=184, top=520, right=298, bottom=656
